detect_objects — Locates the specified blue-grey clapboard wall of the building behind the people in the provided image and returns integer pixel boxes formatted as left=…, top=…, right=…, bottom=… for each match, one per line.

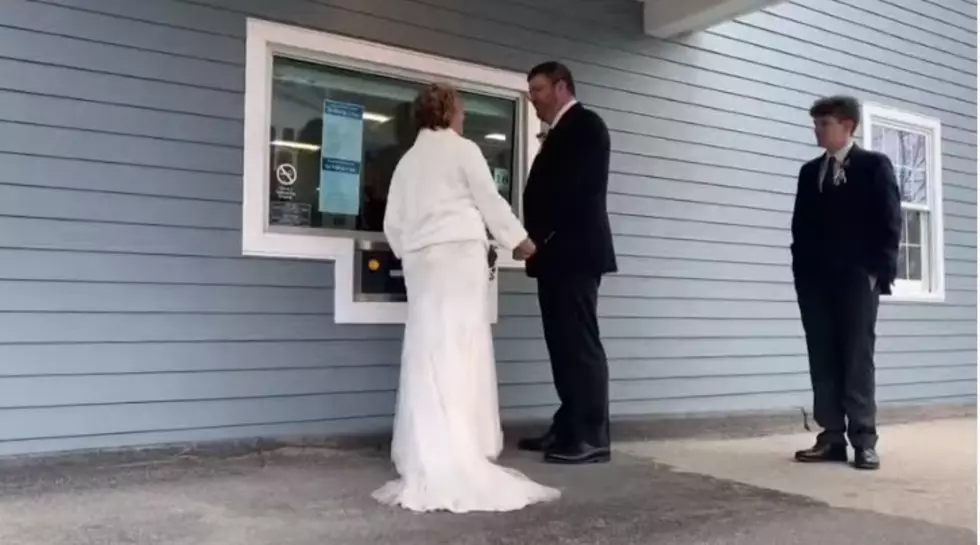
left=0, top=0, right=977, bottom=455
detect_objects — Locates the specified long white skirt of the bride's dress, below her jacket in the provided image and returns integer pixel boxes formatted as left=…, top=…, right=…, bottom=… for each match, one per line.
left=374, top=242, right=560, bottom=513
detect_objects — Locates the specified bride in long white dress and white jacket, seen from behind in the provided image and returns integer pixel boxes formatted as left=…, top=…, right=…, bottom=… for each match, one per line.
left=373, top=84, right=560, bottom=513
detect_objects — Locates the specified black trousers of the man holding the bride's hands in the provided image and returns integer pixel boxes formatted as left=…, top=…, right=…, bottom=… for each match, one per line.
left=538, top=275, right=609, bottom=447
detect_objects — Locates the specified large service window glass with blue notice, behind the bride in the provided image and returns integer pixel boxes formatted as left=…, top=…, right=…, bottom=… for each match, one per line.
left=269, top=57, right=517, bottom=232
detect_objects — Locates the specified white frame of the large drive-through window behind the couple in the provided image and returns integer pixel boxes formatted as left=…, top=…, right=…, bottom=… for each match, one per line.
left=242, top=18, right=541, bottom=323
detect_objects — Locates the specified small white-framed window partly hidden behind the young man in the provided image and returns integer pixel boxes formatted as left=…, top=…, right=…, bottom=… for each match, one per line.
left=862, top=104, right=946, bottom=301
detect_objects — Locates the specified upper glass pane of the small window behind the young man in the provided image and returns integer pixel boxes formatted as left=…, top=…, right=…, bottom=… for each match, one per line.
left=871, top=125, right=928, bottom=204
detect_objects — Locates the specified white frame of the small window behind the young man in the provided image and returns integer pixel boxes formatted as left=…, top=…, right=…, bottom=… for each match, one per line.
left=861, top=104, right=946, bottom=302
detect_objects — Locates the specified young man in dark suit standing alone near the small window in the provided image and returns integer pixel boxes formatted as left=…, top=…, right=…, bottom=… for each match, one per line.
left=791, top=96, right=902, bottom=469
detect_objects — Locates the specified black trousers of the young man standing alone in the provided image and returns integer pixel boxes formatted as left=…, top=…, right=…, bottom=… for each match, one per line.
left=794, top=266, right=879, bottom=449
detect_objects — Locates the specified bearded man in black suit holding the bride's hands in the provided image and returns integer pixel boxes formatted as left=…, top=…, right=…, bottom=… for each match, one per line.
left=514, top=62, right=616, bottom=464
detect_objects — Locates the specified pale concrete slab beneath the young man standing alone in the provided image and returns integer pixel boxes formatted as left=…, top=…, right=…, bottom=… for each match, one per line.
left=621, top=418, right=977, bottom=532
